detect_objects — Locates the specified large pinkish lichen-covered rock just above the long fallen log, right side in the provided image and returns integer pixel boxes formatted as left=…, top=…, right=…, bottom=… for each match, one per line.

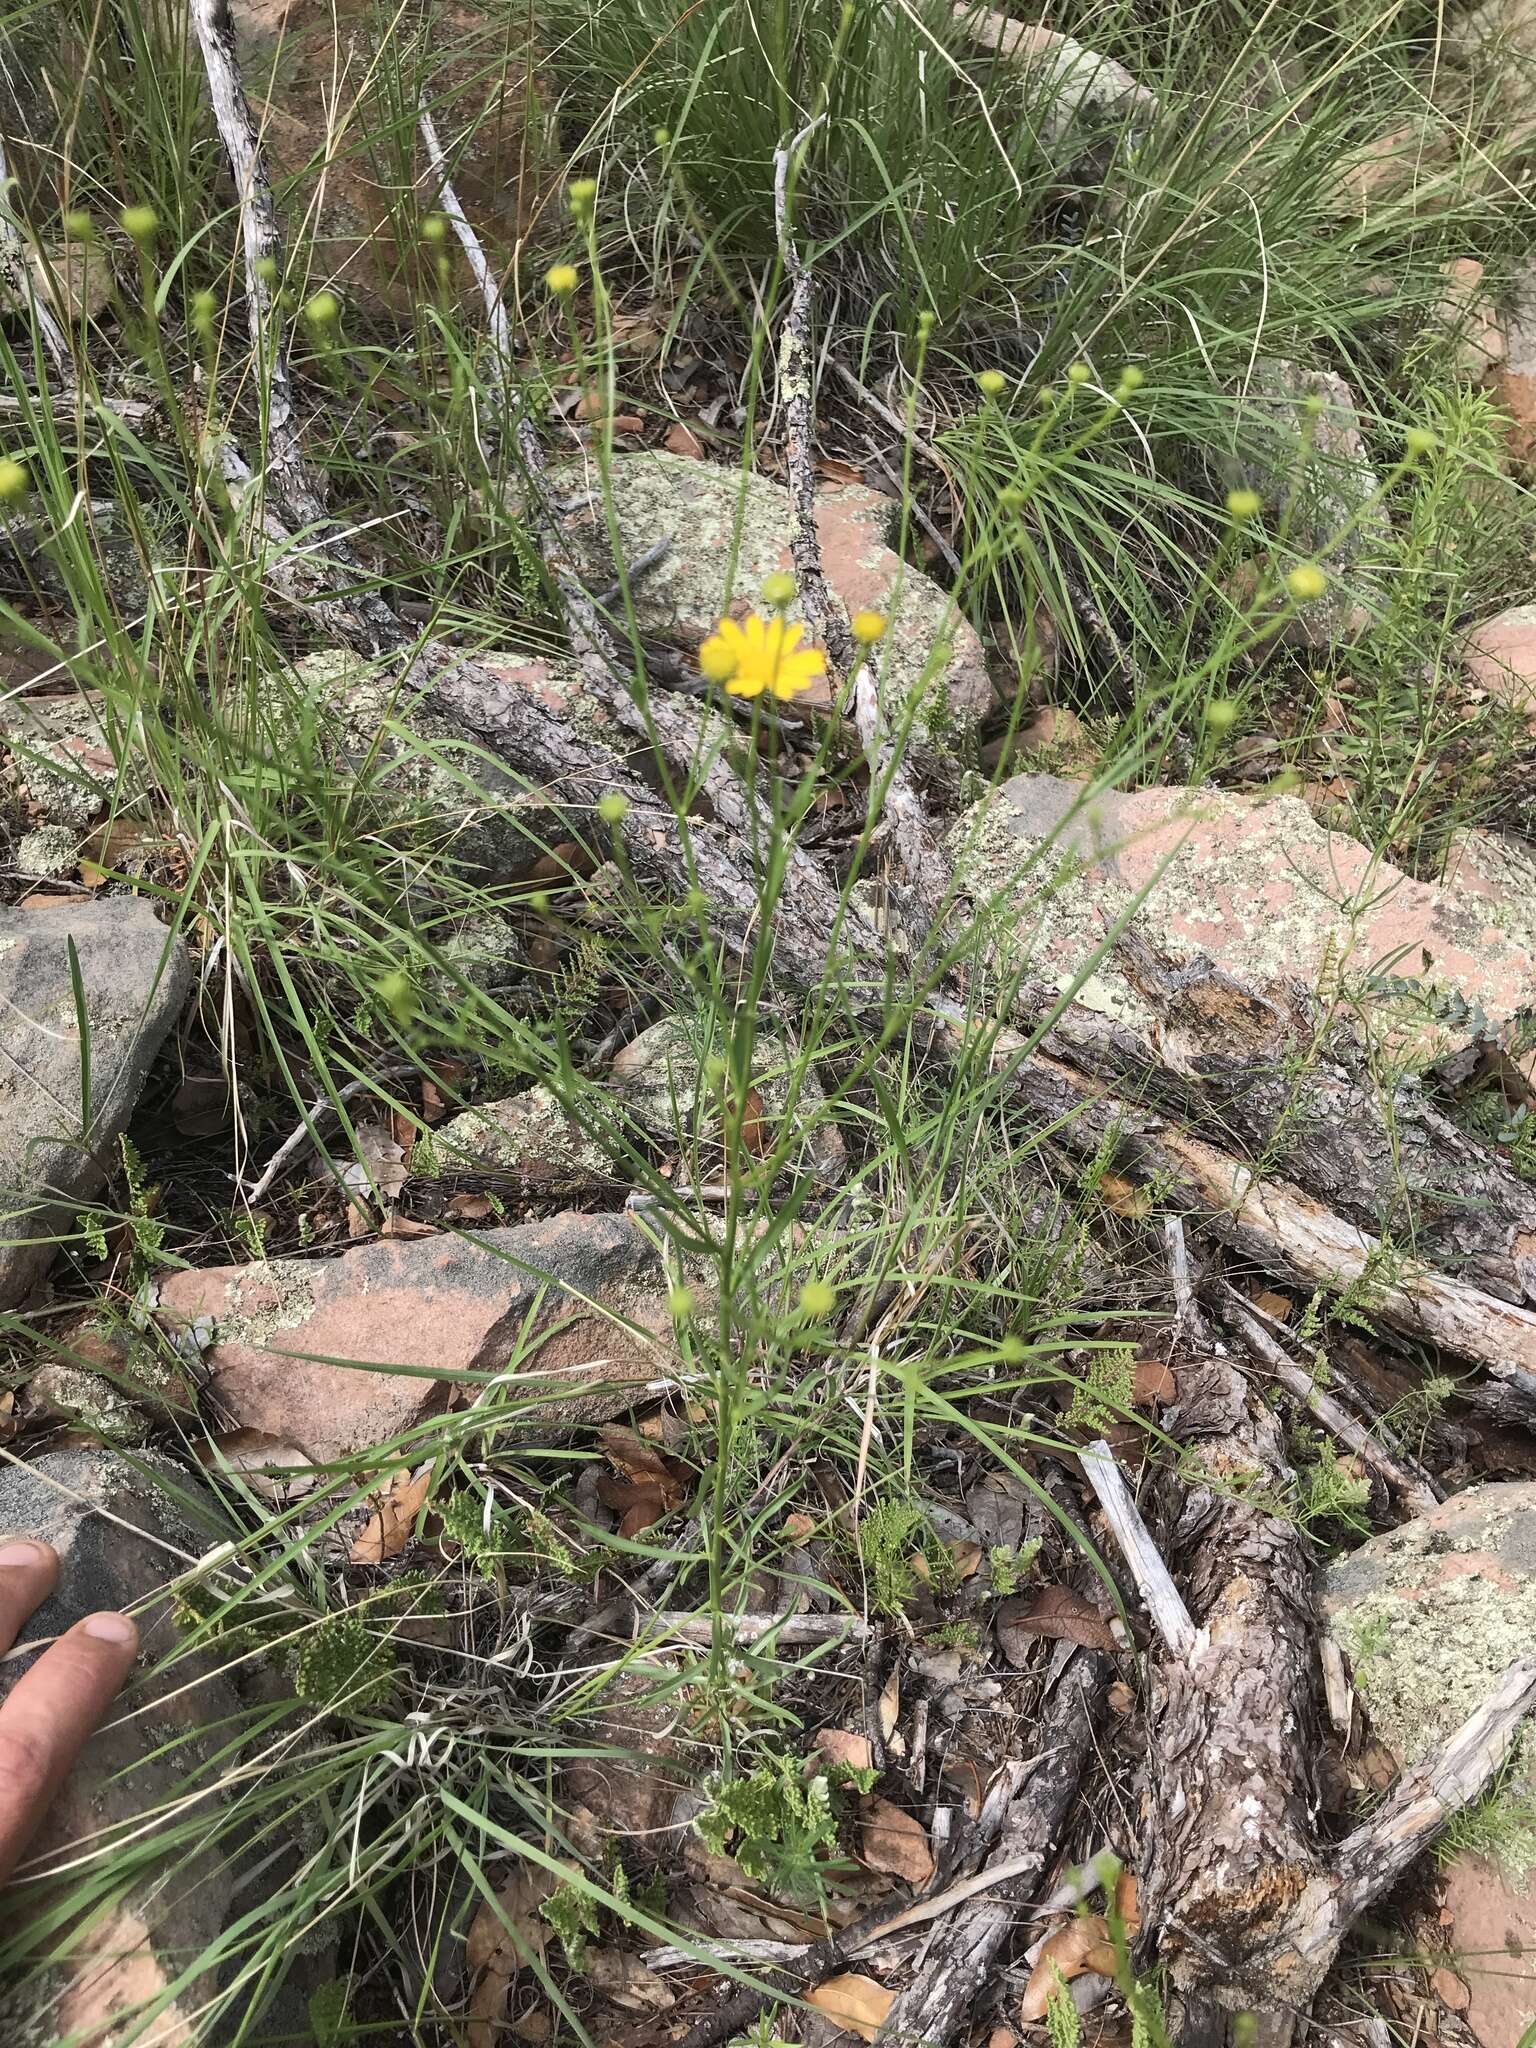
left=952, top=774, right=1536, bottom=1065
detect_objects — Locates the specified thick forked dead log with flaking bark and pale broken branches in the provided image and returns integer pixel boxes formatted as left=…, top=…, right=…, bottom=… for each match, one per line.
left=1085, top=1358, right=1536, bottom=2044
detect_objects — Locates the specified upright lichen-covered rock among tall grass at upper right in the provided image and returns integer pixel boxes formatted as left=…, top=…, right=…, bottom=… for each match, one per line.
left=1235, top=358, right=1391, bottom=647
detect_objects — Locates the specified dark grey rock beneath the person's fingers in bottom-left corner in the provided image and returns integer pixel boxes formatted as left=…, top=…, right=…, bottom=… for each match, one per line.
left=0, top=1450, right=240, bottom=2048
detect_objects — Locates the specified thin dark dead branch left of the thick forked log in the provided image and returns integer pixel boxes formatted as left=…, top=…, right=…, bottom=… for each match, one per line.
left=874, top=1651, right=1110, bottom=2048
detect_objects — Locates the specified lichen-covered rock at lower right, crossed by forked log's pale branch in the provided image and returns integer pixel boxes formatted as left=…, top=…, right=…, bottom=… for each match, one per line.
left=1321, top=1481, right=1536, bottom=2048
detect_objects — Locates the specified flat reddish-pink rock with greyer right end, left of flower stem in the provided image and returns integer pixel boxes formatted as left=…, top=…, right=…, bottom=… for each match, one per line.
left=160, top=1212, right=676, bottom=1462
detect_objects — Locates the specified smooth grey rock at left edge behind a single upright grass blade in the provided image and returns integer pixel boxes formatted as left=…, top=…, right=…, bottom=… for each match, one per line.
left=0, top=897, right=193, bottom=1309
